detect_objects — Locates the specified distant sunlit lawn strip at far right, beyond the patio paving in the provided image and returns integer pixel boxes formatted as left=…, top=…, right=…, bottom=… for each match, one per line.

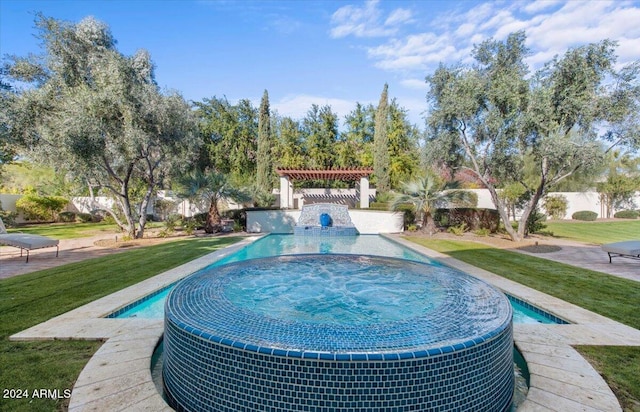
left=544, top=219, right=640, bottom=245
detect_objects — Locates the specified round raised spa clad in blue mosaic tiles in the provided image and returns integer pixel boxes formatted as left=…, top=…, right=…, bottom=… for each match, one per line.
left=163, top=255, right=514, bottom=412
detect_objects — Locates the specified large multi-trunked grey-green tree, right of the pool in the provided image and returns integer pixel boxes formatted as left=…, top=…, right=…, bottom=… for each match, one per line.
left=427, top=32, right=640, bottom=241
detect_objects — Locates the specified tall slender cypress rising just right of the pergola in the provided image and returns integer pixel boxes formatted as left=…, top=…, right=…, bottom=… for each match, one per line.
left=373, top=83, right=391, bottom=193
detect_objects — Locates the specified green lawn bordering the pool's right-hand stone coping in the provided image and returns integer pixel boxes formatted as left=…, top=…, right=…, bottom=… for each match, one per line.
left=406, top=237, right=640, bottom=411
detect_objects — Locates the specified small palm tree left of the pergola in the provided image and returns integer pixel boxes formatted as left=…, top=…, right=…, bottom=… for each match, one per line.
left=178, top=169, right=248, bottom=233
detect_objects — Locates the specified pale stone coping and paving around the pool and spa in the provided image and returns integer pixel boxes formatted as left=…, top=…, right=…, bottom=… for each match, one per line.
left=10, top=235, right=640, bottom=411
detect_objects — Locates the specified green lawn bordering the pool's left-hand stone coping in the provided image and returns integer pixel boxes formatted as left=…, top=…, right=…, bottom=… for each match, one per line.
left=0, top=237, right=241, bottom=412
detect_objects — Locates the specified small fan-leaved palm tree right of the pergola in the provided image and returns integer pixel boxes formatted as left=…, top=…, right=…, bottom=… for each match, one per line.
left=391, top=173, right=471, bottom=234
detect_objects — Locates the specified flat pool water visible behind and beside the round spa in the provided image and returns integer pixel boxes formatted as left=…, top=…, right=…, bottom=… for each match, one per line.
left=110, top=235, right=564, bottom=324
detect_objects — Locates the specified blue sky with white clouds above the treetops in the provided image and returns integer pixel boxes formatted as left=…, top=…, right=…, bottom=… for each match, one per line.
left=0, top=0, right=640, bottom=128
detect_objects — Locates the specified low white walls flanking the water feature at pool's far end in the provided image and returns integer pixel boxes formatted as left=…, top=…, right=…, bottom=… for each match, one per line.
left=247, top=210, right=403, bottom=235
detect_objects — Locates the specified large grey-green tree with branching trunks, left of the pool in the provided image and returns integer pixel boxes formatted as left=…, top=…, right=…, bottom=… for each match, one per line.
left=7, top=15, right=199, bottom=237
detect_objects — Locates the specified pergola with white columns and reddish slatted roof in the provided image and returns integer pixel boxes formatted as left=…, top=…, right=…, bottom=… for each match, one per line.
left=276, top=167, right=373, bottom=209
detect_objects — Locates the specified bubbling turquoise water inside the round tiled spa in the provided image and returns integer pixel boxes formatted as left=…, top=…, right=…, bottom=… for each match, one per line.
left=223, top=255, right=446, bottom=325
